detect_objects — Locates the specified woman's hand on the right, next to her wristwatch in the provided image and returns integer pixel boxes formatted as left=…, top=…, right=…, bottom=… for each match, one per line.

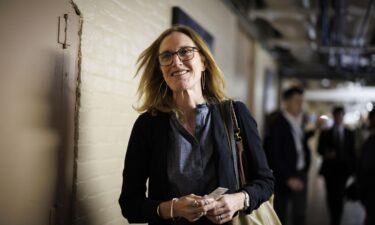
left=206, top=192, right=245, bottom=224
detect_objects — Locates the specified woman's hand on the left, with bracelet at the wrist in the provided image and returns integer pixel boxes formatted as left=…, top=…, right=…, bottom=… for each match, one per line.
left=160, top=194, right=215, bottom=222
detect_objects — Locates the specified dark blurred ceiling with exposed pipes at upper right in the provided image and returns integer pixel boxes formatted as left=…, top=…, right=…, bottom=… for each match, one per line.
left=224, top=0, right=375, bottom=85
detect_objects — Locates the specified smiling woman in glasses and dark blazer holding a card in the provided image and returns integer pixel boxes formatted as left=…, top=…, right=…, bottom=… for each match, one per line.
left=119, top=26, right=274, bottom=224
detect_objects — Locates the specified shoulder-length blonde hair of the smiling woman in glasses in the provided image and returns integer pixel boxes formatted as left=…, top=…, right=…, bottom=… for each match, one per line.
left=135, top=25, right=227, bottom=112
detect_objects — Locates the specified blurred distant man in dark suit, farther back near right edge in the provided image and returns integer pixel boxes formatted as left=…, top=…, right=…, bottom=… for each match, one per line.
left=318, top=107, right=355, bottom=225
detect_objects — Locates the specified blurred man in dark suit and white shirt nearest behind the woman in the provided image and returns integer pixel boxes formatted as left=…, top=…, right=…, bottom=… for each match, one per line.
left=264, top=87, right=313, bottom=225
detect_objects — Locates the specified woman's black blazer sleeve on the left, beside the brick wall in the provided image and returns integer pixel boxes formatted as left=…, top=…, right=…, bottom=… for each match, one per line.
left=119, top=114, right=161, bottom=223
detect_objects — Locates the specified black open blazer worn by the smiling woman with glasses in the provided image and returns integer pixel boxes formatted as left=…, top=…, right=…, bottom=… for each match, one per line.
left=119, top=102, right=274, bottom=224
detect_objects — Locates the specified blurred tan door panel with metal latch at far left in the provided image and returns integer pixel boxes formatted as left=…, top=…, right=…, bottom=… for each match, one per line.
left=0, top=0, right=80, bottom=225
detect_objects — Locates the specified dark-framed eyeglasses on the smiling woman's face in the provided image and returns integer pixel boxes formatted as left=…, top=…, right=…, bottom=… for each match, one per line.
left=158, top=46, right=199, bottom=66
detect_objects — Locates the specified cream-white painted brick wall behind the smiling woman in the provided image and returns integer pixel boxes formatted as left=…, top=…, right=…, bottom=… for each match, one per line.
left=74, top=0, right=250, bottom=225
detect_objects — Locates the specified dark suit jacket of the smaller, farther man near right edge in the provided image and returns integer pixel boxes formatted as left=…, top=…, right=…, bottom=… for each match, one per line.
left=318, top=125, right=356, bottom=176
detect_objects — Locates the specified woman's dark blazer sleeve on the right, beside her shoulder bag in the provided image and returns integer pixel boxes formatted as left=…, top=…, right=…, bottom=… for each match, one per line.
left=234, top=102, right=274, bottom=213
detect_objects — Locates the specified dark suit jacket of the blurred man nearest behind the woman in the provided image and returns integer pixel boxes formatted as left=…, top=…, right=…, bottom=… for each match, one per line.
left=264, top=112, right=313, bottom=192
